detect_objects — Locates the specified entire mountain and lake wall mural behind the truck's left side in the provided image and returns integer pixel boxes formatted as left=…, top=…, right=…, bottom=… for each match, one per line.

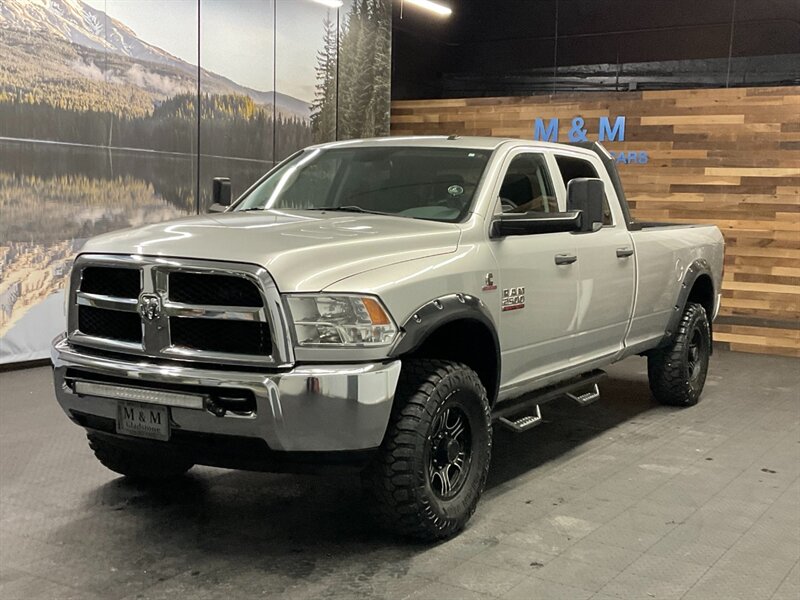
left=0, top=0, right=391, bottom=363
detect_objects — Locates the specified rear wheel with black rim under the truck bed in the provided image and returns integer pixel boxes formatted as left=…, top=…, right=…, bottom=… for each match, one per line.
left=647, top=303, right=711, bottom=406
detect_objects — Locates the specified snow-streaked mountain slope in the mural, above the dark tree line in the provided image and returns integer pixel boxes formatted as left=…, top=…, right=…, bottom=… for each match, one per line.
left=0, top=0, right=311, bottom=120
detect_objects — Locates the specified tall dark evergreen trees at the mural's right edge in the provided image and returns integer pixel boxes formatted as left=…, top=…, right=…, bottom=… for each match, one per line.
left=312, top=0, right=391, bottom=139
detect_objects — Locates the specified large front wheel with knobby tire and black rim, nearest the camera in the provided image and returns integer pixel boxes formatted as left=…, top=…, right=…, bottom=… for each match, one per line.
left=363, top=359, right=492, bottom=540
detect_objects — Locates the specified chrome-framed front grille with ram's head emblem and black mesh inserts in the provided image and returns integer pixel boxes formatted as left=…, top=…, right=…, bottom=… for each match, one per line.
left=68, top=255, right=292, bottom=366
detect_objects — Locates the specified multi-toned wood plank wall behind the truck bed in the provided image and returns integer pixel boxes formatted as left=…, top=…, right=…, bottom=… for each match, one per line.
left=392, top=87, right=800, bottom=356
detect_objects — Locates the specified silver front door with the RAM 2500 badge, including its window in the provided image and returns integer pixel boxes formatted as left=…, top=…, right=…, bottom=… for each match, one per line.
left=484, top=148, right=577, bottom=388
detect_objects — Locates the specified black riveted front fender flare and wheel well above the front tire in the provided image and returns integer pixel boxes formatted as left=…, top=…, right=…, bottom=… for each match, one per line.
left=390, top=293, right=501, bottom=405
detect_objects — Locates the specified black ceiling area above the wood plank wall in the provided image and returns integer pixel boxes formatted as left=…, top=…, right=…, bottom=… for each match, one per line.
left=392, top=0, right=800, bottom=99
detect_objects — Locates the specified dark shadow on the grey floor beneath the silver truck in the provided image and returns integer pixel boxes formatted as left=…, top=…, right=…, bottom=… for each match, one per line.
left=55, top=372, right=656, bottom=594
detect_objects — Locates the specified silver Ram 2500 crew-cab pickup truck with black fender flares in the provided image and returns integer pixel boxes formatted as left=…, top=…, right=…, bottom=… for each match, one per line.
left=52, top=136, right=723, bottom=539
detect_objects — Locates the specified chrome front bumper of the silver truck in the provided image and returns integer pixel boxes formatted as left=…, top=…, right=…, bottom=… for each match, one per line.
left=51, top=338, right=400, bottom=452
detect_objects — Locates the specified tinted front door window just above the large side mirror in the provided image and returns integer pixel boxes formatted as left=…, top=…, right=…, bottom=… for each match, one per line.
left=500, top=154, right=558, bottom=213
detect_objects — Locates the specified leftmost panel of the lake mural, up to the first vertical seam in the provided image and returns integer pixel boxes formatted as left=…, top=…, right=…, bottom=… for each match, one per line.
left=0, top=0, right=197, bottom=362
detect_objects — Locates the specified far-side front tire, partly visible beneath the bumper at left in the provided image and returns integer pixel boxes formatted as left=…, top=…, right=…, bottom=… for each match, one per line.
left=86, top=433, right=194, bottom=481
